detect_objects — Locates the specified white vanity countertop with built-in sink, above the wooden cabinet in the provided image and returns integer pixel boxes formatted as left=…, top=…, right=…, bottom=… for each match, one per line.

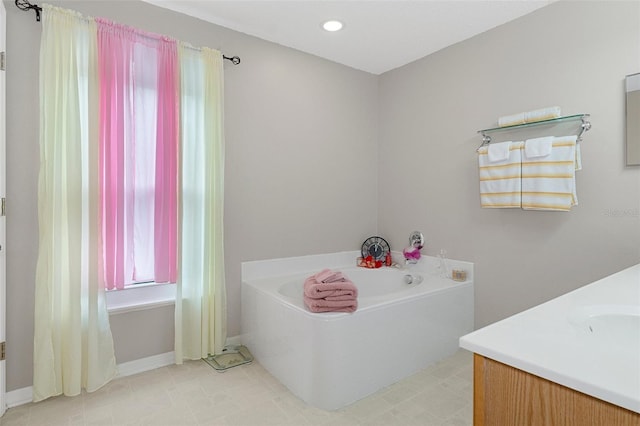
left=460, top=264, right=640, bottom=413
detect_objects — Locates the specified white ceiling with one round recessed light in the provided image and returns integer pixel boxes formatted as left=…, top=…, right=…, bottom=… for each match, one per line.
left=145, top=0, right=555, bottom=74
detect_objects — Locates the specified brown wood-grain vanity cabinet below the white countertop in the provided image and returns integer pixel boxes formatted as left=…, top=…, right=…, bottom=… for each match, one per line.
left=473, top=354, right=640, bottom=426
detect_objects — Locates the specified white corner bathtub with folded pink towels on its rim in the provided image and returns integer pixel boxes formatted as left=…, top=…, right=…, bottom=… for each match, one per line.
left=241, top=252, right=474, bottom=410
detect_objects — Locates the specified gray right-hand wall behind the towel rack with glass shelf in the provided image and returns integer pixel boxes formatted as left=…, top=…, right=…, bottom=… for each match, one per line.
left=378, top=2, right=640, bottom=327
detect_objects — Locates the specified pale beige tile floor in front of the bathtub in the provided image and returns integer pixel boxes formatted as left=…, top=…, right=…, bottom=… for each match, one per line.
left=0, top=350, right=473, bottom=426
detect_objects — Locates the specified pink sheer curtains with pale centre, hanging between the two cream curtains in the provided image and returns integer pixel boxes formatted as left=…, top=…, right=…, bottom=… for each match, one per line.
left=96, top=18, right=179, bottom=289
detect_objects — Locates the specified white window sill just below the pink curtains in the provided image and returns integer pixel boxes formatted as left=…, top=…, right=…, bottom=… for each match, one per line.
left=105, top=284, right=176, bottom=315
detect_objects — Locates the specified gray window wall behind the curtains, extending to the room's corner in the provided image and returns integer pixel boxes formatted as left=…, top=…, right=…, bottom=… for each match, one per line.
left=5, top=1, right=378, bottom=391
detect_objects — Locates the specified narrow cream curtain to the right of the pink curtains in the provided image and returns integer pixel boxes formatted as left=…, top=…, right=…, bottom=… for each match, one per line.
left=175, top=44, right=227, bottom=364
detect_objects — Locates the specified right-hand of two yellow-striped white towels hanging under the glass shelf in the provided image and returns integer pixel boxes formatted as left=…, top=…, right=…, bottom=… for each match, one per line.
left=522, top=136, right=578, bottom=211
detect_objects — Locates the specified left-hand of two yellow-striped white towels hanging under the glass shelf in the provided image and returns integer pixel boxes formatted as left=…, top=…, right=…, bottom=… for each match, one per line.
left=478, top=142, right=523, bottom=208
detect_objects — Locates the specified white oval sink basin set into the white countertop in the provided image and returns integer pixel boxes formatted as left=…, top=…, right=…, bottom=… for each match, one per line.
left=569, top=305, right=640, bottom=344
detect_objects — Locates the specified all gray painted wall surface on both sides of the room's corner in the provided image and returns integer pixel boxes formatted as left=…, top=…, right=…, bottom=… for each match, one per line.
left=5, top=1, right=640, bottom=391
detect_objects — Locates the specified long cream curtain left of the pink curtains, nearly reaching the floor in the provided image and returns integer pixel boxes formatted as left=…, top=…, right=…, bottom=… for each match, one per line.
left=33, top=4, right=116, bottom=401
